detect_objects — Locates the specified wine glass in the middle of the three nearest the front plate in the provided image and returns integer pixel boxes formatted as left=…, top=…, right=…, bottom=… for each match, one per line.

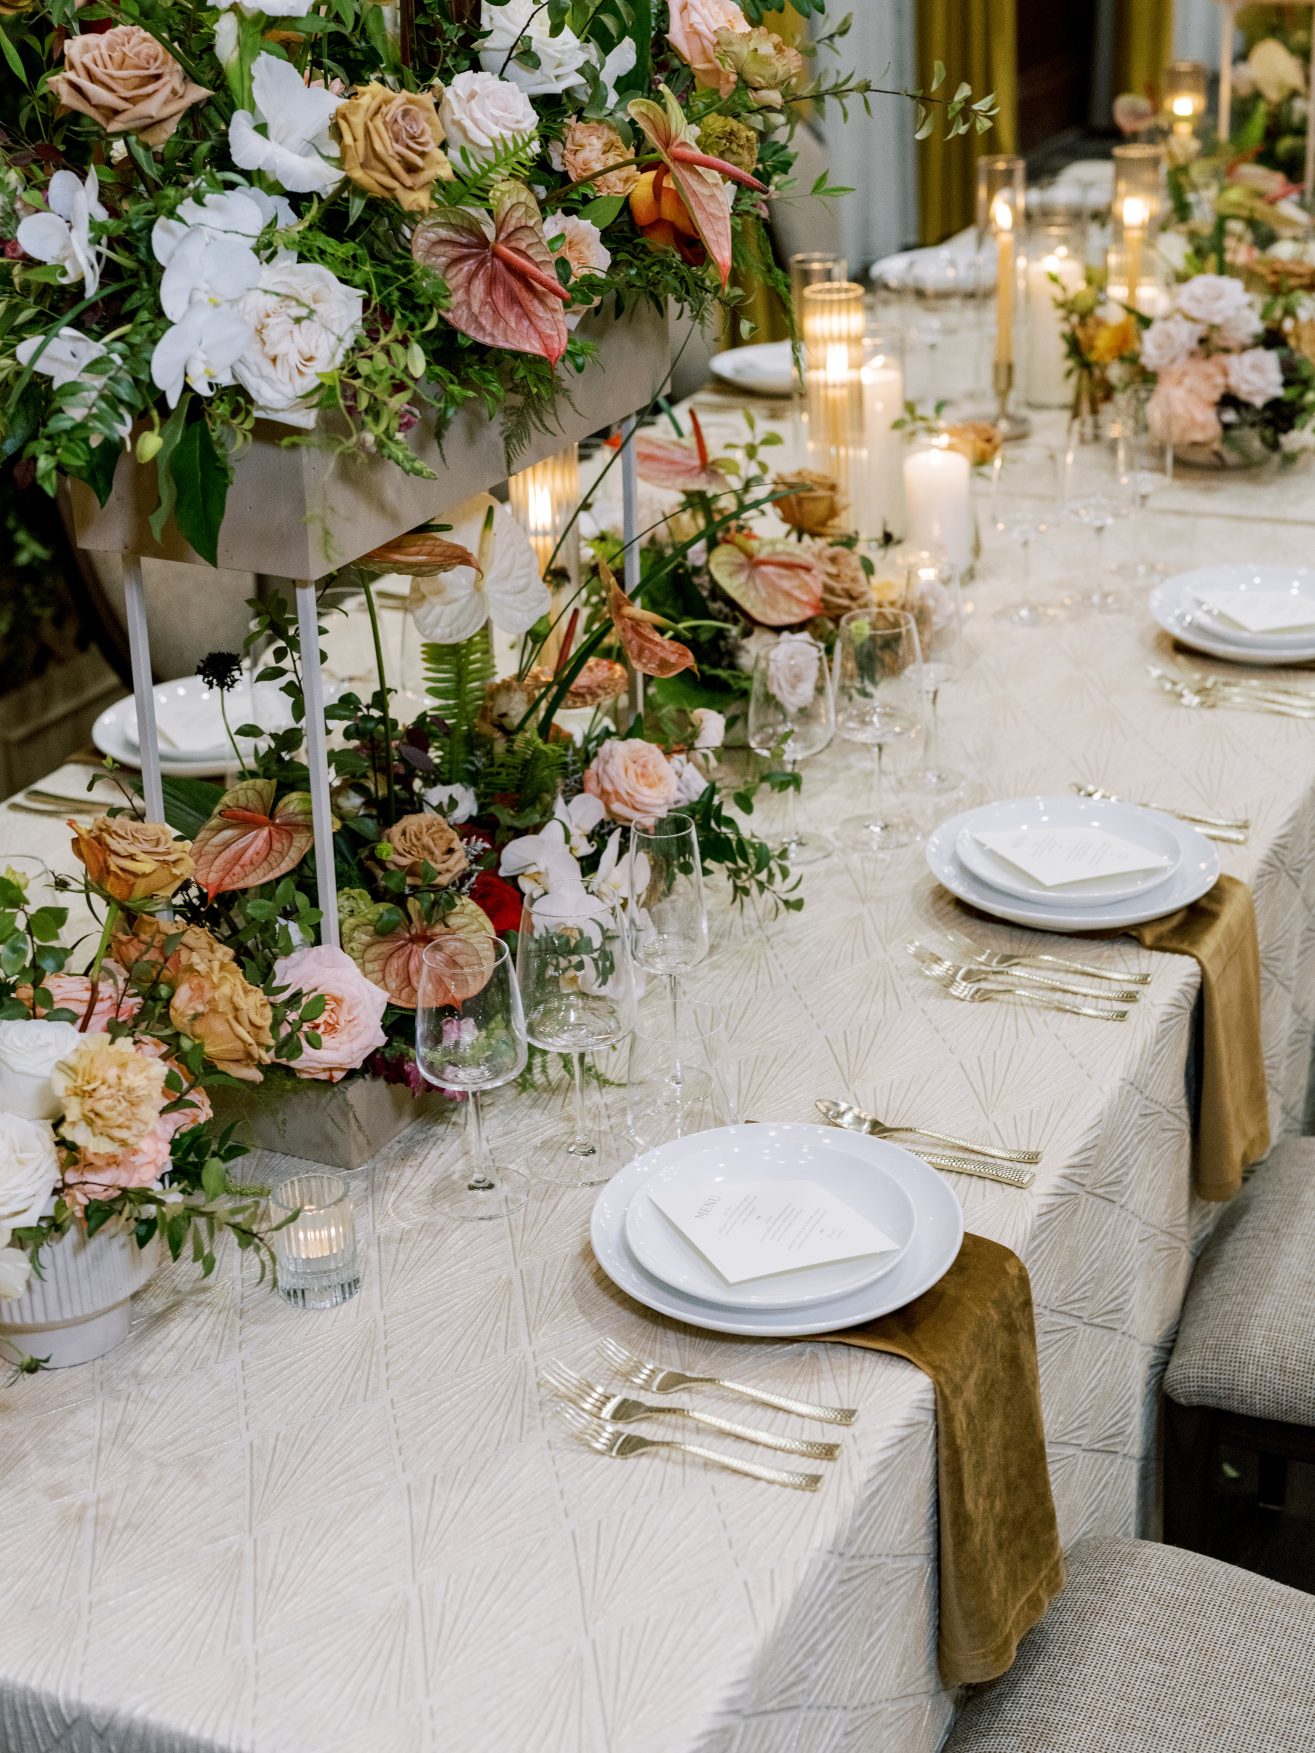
left=515, top=885, right=635, bottom=1187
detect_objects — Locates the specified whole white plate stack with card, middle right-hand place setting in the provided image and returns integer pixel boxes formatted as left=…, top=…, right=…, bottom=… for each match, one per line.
left=928, top=798, right=1219, bottom=931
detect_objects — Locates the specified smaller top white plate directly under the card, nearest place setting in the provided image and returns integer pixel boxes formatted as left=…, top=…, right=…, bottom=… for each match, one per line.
left=626, top=1125, right=913, bottom=1309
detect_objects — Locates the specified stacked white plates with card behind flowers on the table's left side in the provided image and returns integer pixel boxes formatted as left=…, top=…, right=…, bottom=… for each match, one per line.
left=91, top=675, right=301, bottom=778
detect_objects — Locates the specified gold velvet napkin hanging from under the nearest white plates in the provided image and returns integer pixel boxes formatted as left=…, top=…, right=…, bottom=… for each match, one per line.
left=824, top=1234, right=1064, bottom=1686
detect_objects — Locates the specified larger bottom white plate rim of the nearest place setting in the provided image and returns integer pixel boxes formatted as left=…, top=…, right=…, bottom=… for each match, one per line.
left=589, top=1122, right=963, bottom=1339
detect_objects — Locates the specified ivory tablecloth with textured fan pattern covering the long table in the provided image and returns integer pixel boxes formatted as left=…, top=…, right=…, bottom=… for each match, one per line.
left=0, top=413, right=1315, bottom=1753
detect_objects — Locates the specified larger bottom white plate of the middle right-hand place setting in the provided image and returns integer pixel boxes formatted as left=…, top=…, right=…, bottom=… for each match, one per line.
left=928, top=798, right=1219, bottom=931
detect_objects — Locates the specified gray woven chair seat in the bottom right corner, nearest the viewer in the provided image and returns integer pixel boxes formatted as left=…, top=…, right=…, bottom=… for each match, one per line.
left=942, top=1539, right=1315, bottom=1753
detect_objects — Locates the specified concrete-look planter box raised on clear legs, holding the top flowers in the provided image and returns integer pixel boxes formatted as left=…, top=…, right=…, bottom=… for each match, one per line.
left=72, top=305, right=670, bottom=578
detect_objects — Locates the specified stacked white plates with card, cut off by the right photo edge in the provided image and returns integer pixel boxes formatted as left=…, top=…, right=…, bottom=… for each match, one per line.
left=1150, top=564, right=1315, bottom=666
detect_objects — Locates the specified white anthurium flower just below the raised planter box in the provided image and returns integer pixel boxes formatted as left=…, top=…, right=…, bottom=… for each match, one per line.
left=410, top=493, right=549, bottom=645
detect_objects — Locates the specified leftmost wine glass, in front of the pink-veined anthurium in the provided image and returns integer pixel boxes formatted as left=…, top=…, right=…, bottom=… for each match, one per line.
left=416, top=938, right=530, bottom=1218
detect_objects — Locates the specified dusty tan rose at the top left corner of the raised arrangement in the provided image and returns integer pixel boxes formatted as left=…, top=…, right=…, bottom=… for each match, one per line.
left=49, top=25, right=210, bottom=145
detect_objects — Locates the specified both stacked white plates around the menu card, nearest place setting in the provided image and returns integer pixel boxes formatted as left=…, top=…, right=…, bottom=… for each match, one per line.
left=591, top=1122, right=963, bottom=1338
